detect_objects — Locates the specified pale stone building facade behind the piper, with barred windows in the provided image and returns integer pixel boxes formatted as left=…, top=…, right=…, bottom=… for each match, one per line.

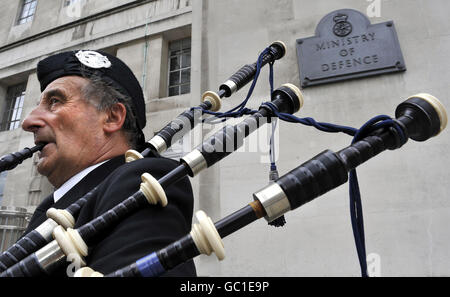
left=0, top=0, right=450, bottom=276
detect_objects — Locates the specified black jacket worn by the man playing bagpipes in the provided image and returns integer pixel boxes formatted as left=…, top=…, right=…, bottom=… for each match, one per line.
left=22, top=156, right=196, bottom=277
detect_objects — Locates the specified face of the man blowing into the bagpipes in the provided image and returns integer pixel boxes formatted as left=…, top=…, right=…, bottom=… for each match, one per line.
left=22, top=76, right=106, bottom=187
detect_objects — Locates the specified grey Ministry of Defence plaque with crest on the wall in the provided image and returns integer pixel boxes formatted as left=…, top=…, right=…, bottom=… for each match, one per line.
left=297, top=9, right=406, bottom=87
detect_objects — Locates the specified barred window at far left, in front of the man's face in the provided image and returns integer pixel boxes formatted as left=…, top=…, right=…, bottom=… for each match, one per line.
left=0, top=84, right=26, bottom=131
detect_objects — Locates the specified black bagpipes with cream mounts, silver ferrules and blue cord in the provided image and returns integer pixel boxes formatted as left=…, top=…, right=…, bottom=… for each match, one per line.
left=0, top=38, right=447, bottom=277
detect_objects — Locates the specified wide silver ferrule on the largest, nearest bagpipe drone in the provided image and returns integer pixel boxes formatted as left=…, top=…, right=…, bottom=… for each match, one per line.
left=253, top=183, right=291, bottom=222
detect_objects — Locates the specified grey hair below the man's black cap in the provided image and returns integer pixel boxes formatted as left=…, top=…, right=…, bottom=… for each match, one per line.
left=82, top=75, right=139, bottom=149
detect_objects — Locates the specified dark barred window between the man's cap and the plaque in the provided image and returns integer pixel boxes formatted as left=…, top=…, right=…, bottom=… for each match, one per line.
left=168, top=38, right=191, bottom=96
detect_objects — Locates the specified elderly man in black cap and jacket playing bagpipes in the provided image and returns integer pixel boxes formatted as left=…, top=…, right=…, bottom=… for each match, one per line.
left=11, top=51, right=196, bottom=276
